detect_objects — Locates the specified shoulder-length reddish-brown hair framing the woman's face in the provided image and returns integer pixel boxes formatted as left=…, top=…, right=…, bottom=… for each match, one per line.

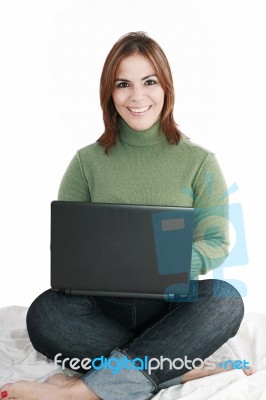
left=97, top=32, right=182, bottom=153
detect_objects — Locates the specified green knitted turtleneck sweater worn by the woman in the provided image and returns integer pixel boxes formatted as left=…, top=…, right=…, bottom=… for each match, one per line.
left=58, top=120, right=229, bottom=279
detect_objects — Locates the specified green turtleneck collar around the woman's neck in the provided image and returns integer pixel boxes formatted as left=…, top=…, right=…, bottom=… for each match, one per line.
left=119, top=118, right=167, bottom=146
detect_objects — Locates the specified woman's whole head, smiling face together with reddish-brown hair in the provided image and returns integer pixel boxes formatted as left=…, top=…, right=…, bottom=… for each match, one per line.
left=98, top=32, right=182, bottom=152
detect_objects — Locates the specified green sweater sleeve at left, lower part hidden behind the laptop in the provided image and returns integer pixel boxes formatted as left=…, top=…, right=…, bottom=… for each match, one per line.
left=58, top=151, right=91, bottom=202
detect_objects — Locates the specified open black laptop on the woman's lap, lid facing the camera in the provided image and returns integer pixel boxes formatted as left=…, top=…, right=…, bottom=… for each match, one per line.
left=51, top=201, right=194, bottom=300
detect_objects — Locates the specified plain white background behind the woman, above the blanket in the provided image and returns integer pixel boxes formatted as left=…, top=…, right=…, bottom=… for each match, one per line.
left=0, top=0, right=266, bottom=312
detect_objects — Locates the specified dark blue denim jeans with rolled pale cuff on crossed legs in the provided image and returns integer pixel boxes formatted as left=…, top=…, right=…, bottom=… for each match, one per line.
left=27, top=279, right=244, bottom=400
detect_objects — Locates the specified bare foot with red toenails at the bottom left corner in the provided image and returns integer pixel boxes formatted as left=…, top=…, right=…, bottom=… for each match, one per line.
left=0, top=374, right=100, bottom=400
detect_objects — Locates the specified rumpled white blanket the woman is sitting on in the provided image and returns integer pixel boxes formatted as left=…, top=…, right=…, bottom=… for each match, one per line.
left=0, top=306, right=266, bottom=400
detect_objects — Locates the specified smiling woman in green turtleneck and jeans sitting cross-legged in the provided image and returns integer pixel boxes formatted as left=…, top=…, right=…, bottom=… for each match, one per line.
left=1, top=32, right=244, bottom=400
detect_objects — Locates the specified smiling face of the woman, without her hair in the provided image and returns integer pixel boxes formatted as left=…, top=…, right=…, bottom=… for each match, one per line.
left=112, top=54, right=164, bottom=131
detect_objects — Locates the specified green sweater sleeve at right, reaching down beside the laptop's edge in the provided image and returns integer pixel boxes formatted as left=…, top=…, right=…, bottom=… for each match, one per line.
left=191, top=154, right=229, bottom=279
